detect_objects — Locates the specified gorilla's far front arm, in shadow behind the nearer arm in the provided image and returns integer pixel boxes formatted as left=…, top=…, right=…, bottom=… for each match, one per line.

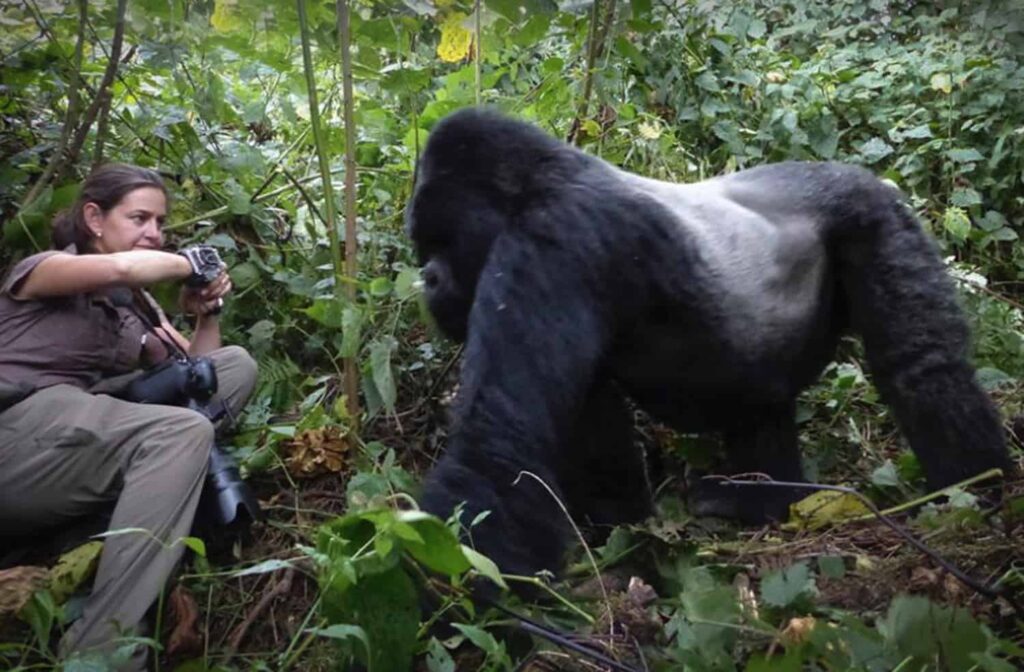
left=561, top=379, right=650, bottom=527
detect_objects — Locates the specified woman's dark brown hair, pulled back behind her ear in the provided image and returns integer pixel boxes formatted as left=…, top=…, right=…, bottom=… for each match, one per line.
left=50, top=163, right=167, bottom=254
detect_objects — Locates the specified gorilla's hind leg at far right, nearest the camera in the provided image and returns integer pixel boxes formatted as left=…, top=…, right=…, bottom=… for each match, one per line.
left=836, top=191, right=1010, bottom=488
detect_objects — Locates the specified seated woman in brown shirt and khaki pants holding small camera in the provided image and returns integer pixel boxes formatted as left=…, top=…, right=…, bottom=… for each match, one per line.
left=0, top=165, right=256, bottom=669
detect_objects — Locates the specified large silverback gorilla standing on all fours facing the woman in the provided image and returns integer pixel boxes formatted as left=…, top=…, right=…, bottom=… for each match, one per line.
left=407, top=110, right=1010, bottom=574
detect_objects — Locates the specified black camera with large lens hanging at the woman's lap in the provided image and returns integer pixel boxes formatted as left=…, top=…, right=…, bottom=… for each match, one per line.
left=118, top=358, right=263, bottom=526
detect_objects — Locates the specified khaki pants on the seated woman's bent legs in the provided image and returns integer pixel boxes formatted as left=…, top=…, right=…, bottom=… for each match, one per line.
left=0, top=346, right=256, bottom=669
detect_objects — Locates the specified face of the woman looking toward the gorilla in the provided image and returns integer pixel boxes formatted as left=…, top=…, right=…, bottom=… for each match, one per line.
left=83, top=186, right=167, bottom=253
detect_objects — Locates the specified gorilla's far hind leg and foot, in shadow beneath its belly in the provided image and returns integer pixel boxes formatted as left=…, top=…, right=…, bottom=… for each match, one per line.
left=690, top=402, right=806, bottom=523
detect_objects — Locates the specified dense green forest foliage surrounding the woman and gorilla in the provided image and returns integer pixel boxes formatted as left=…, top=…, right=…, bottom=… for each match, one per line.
left=0, top=0, right=1024, bottom=672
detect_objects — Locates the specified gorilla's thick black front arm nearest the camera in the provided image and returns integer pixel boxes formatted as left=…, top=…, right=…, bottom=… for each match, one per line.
left=422, top=233, right=609, bottom=575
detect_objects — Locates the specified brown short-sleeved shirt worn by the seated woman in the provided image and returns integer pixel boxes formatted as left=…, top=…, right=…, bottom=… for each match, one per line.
left=0, top=248, right=146, bottom=399
